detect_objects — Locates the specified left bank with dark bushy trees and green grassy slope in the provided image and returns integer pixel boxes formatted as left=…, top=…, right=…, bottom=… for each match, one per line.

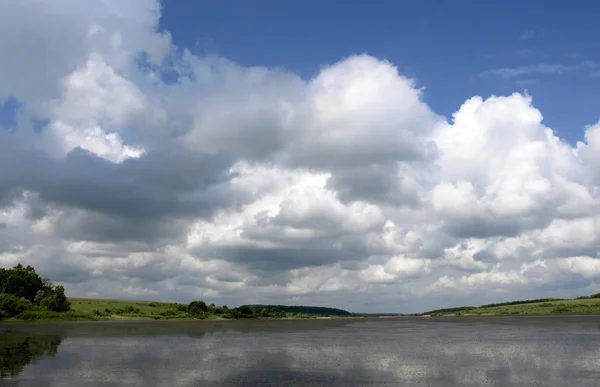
left=0, top=264, right=352, bottom=321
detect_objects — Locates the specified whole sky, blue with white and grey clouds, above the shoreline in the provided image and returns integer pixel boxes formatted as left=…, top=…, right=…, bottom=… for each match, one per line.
left=0, top=0, right=600, bottom=313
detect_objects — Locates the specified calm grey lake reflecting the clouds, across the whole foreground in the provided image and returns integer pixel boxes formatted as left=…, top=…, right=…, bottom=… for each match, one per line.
left=0, top=316, right=600, bottom=387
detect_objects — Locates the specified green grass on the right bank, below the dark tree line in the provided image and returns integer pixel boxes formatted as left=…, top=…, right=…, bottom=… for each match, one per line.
left=433, top=298, right=600, bottom=316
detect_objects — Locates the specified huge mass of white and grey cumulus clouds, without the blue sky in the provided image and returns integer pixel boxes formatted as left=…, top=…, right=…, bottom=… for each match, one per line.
left=0, top=0, right=600, bottom=312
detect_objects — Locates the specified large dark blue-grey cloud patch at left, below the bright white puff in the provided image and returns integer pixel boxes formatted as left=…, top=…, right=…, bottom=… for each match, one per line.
left=0, top=136, right=245, bottom=238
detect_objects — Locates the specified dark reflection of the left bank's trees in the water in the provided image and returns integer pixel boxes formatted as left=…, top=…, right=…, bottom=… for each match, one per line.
left=0, top=336, right=62, bottom=378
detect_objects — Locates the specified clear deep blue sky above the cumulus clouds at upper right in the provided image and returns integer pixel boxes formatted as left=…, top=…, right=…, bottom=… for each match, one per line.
left=160, top=0, right=600, bottom=144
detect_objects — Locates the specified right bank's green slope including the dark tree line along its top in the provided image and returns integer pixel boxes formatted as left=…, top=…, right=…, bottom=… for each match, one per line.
left=423, top=293, right=600, bottom=316
